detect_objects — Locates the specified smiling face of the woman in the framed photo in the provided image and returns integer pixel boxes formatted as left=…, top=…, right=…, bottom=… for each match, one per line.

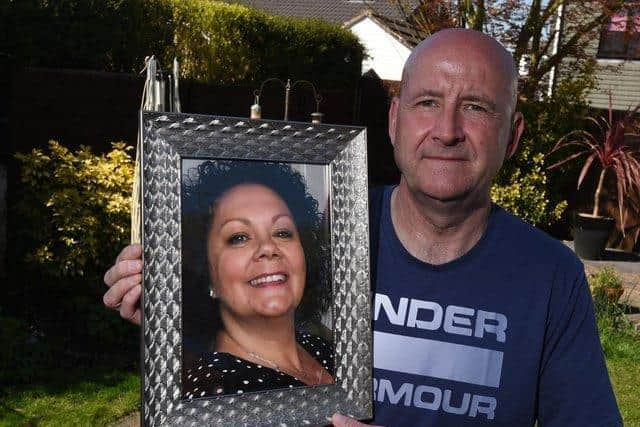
left=207, top=184, right=306, bottom=318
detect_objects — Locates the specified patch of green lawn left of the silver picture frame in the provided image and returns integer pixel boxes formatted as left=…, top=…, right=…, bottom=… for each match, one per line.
left=0, top=372, right=140, bottom=427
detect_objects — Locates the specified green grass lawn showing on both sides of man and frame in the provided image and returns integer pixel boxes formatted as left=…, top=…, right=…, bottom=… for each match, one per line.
left=0, top=318, right=640, bottom=427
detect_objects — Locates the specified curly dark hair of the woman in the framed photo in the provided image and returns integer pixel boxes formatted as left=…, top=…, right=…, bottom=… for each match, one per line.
left=182, top=160, right=331, bottom=347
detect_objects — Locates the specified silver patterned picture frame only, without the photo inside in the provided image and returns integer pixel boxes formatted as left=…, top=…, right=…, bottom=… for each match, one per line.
left=140, top=112, right=373, bottom=426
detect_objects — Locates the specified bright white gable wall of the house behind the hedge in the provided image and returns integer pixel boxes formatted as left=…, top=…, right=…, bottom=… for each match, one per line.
left=350, top=18, right=411, bottom=81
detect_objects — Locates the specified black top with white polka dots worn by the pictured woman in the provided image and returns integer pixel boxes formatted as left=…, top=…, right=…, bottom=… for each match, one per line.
left=182, top=334, right=333, bottom=400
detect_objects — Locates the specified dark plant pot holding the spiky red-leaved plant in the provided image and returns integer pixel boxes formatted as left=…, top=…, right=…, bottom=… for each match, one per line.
left=573, top=214, right=615, bottom=260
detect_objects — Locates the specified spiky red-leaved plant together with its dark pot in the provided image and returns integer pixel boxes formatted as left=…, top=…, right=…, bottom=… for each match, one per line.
left=549, top=93, right=640, bottom=259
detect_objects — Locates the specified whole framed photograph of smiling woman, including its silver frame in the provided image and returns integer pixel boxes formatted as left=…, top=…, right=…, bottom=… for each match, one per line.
left=140, top=112, right=372, bottom=426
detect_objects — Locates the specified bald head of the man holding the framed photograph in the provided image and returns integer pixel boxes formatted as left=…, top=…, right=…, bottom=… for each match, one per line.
left=389, top=29, right=524, bottom=206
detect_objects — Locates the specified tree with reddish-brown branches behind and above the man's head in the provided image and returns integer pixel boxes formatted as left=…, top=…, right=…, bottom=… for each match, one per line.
left=389, top=0, right=625, bottom=100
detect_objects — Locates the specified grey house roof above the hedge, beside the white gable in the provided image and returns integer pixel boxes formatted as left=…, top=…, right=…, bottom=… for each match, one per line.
left=230, top=0, right=418, bottom=25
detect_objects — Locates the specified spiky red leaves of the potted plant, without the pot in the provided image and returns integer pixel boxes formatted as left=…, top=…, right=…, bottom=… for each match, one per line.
left=549, top=93, right=640, bottom=234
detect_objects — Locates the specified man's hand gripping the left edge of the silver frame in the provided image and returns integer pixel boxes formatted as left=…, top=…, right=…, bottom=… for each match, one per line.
left=102, top=245, right=142, bottom=325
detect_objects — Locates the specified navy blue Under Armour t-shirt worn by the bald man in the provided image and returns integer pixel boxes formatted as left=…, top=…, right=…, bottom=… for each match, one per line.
left=372, top=187, right=622, bottom=427
